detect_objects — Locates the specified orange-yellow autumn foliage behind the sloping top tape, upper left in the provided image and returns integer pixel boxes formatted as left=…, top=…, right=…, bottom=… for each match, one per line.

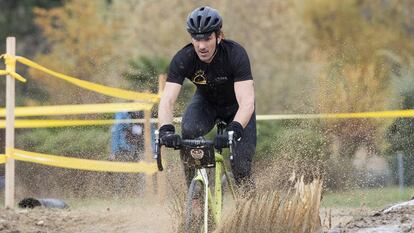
left=30, top=0, right=125, bottom=104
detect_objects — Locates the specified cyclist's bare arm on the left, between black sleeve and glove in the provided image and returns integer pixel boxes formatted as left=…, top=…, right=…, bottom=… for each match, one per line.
left=158, top=82, right=181, bottom=126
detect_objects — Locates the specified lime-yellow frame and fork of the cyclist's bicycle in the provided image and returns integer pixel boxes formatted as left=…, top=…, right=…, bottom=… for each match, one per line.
left=193, top=152, right=236, bottom=232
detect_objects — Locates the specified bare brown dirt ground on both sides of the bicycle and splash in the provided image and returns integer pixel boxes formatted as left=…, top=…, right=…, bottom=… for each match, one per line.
left=0, top=198, right=414, bottom=233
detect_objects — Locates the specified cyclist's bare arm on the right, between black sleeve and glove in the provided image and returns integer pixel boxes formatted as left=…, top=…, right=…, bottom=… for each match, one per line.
left=234, top=80, right=254, bottom=128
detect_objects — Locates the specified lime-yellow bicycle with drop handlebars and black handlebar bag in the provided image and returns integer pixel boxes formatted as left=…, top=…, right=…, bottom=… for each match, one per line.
left=154, top=121, right=236, bottom=232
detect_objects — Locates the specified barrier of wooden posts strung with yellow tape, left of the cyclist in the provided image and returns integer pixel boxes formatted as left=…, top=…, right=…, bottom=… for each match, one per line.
left=0, top=37, right=164, bottom=208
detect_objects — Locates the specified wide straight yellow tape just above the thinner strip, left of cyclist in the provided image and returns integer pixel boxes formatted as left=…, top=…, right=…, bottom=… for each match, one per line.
left=0, top=102, right=153, bottom=117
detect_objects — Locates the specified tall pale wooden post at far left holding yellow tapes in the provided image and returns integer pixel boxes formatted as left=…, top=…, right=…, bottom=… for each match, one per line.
left=5, top=37, right=16, bottom=208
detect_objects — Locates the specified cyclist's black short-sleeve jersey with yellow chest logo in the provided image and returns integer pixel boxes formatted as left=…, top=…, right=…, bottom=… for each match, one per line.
left=167, top=40, right=253, bottom=106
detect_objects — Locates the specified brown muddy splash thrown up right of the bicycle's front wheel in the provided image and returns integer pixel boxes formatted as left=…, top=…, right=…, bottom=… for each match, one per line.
left=215, top=177, right=322, bottom=233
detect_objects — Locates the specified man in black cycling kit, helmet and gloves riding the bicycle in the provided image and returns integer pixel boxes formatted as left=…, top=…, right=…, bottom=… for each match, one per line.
left=158, top=6, right=256, bottom=195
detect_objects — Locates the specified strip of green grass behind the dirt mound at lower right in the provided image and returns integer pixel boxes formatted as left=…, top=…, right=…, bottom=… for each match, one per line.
left=321, top=187, right=414, bottom=209
